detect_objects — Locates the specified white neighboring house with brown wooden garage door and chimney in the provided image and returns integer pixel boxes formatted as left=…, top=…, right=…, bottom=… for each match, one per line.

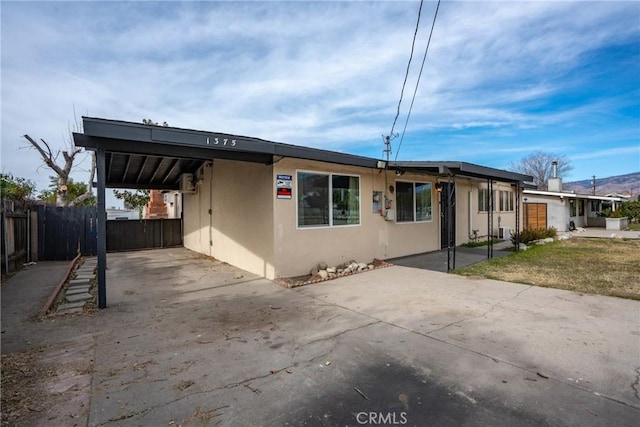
left=523, top=177, right=624, bottom=231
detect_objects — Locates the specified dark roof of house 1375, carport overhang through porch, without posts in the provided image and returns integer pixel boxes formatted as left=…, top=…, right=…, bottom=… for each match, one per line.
left=73, top=117, right=533, bottom=189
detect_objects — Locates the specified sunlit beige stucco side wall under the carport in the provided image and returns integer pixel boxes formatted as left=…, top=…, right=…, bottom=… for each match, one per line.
left=184, top=160, right=274, bottom=278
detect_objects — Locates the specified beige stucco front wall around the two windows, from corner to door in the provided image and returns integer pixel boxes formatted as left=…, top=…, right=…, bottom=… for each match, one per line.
left=274, top=158, right=439, bottom=277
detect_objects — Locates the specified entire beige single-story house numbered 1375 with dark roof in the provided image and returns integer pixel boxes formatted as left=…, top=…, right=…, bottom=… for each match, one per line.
left=74, top=117, right=532, bottom=305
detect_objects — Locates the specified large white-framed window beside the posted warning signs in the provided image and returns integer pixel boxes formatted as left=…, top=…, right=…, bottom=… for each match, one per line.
left=297, top=172, right=360, bottom=227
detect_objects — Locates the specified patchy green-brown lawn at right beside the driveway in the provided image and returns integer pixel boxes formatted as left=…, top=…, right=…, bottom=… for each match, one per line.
left=454, top=238, right=640, bottom=300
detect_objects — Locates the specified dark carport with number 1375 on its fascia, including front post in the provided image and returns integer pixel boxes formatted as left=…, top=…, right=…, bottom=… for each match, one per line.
left=73, top=117, right=376, bottom=308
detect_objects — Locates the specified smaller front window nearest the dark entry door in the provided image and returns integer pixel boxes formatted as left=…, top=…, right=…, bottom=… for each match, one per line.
left=396, top=181, right=432, bottom=222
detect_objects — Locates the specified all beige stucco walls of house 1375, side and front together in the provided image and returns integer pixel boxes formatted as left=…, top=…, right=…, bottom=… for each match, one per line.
left=184, top=158, right=515, bottom=279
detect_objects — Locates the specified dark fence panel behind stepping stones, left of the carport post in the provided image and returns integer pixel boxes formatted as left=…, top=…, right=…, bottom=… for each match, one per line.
left=38, top=205, right=97, bottom=261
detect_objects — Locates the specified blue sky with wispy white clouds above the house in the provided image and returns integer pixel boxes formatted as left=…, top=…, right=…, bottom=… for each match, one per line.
left=0, top=1, right=640, bottom=204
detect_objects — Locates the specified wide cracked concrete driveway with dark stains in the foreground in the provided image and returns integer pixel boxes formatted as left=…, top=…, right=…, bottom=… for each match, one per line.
left=3, top=249, right=640, bottom=426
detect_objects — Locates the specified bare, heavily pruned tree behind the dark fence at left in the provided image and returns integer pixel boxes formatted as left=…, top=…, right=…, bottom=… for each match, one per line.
left=24, top=135, right=96, bottom=206
